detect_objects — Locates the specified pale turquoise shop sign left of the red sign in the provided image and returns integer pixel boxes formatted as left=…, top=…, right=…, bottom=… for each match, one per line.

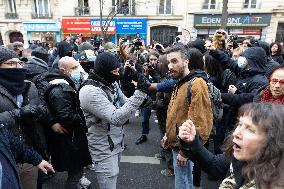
left=23, top=22, right=60, bottom=32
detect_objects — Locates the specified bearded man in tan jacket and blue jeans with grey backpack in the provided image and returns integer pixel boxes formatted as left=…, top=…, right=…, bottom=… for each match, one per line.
left=162, top=45, right=213, bottom=189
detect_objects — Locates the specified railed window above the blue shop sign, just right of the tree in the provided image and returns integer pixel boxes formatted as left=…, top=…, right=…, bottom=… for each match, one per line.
left=112, top=0, right=134, bottom=15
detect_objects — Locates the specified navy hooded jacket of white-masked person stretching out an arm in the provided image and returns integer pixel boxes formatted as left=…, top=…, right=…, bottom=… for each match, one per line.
left=210, top=47, right=268, bottom=107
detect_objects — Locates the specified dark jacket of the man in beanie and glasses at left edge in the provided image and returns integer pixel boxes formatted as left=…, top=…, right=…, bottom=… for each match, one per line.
left=0, top=81, right=48, bottom=158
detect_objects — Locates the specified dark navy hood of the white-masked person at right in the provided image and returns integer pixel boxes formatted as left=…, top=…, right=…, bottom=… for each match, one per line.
left=241, top=47, right=267, bottom=75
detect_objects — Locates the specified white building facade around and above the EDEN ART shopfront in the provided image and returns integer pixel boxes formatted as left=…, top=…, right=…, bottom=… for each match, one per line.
left=187, top=0, right=284, bottom=42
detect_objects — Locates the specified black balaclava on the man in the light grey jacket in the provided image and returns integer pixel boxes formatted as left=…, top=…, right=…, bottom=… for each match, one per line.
left=94, top=52, right=120, bottom=81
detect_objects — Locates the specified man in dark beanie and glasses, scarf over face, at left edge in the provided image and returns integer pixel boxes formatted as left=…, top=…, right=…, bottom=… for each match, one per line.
left=0, top=48, right=52, bottom=189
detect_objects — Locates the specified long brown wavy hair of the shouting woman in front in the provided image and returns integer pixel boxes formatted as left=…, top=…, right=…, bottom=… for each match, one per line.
left=226, top=103, right=284, bottom=189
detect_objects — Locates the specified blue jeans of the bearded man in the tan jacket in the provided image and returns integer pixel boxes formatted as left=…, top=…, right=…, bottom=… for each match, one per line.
left=172, top=150, right=193, bottom=189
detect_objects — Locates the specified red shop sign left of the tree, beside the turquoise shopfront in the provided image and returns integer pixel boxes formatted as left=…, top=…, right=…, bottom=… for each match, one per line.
left=62, top=18, right=91, bottom=33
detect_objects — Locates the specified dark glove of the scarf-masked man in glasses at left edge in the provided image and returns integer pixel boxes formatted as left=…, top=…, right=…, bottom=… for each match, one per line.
left=20, top=104, right=46, bottom=118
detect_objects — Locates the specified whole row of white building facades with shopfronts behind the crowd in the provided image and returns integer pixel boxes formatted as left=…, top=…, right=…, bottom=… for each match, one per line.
left=0, top=0, right=284, bottom=45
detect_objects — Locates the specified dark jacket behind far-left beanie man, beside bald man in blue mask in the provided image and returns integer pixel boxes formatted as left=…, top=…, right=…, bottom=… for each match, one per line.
left=24, top=56, right=48, bottom=81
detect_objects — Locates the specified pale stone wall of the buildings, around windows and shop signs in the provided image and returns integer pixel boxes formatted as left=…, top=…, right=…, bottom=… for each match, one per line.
left=0, top=0, right=284, bottom=44
